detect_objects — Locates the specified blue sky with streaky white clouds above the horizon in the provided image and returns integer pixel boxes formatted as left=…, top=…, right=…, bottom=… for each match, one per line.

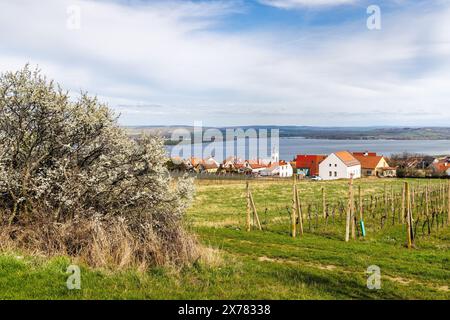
left=0, top=0, right=450, bottom=126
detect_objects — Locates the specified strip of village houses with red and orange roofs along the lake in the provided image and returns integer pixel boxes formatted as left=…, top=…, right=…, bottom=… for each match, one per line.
left=168, top=151, right=450, bottom=180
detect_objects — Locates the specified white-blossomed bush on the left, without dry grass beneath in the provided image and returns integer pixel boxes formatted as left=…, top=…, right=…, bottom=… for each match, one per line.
left=0, top=66, right=197, bottom=268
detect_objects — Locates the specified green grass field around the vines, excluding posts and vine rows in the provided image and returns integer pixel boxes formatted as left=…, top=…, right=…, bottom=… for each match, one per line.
left=0, top=179, right=450, bottom=299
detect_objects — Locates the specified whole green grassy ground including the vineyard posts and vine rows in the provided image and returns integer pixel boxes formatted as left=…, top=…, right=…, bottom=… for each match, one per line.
left=0, top=179, right=450, bottom=300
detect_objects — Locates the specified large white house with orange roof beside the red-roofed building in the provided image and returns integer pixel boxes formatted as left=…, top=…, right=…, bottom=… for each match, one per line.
left=319, top=151, right=361, bottom=180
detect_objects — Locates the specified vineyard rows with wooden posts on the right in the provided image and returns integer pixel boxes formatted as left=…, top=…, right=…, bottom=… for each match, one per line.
left=246, top=180, right=450, bottom=247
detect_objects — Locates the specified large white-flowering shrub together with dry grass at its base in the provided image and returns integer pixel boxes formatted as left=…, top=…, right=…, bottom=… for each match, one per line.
left=0, top=65, right=195, bottom=265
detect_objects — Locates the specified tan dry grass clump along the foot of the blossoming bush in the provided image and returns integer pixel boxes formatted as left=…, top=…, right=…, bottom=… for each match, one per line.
left=0, top=215, right=199, bottom=270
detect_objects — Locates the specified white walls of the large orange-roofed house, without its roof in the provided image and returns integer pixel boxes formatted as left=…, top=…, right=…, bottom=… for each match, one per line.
left=319, top=153, right=361, bottom=180
